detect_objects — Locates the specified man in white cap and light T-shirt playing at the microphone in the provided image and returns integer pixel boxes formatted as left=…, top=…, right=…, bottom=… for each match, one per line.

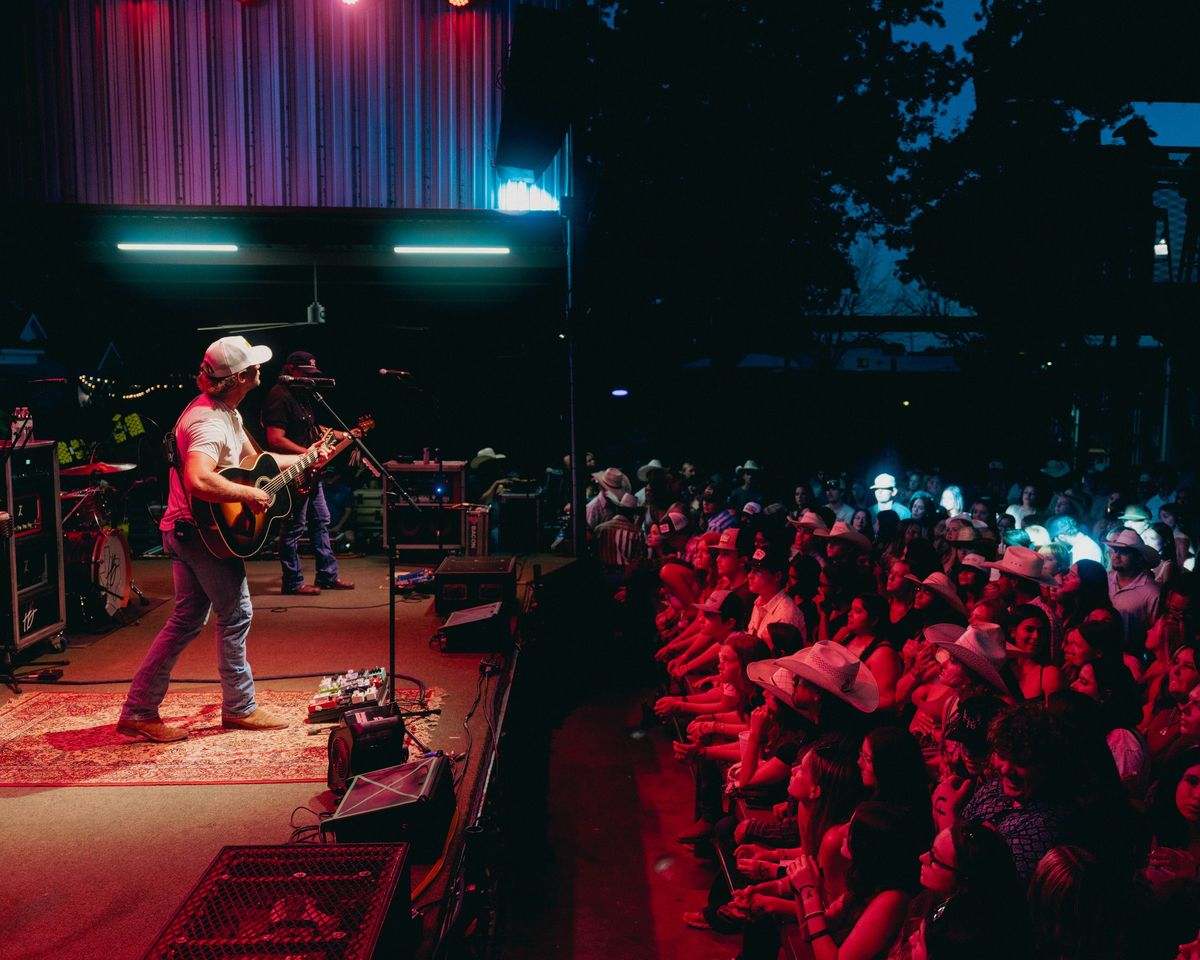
left=116, top=337, right=328, bottom=743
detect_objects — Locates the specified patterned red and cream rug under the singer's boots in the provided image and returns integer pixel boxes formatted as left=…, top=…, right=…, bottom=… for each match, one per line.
left=0, top=688, right=445, bottom=787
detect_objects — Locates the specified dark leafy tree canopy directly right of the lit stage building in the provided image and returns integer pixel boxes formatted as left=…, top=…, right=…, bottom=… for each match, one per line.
left=577, top=0, right=962, bottom=345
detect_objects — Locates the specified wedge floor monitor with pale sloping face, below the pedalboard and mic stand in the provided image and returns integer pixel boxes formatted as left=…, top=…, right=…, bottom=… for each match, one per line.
left=320, top=755, right=455, bottom=863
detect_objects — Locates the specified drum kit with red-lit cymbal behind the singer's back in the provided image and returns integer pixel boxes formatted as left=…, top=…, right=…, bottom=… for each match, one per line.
left=59, top=462, right=149, bottom=630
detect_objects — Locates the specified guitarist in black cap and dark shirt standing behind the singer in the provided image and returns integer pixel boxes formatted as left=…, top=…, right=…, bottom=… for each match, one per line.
left=263, top=350, right=354, bottom=596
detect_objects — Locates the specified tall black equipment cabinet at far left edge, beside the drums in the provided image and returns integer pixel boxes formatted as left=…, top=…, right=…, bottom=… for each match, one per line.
left=0, top=440, right=66, bottom=650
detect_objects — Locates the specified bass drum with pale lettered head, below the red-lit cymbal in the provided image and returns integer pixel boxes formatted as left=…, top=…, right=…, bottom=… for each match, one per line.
left=62, top=528, right=133, bottom=629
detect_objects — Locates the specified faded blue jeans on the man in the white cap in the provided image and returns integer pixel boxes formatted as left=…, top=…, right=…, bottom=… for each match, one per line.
left=121, top=530, right=257, bottom=720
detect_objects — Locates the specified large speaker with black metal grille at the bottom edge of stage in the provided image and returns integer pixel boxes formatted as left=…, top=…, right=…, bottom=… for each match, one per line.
left=145, top=844, right=412, bottom=960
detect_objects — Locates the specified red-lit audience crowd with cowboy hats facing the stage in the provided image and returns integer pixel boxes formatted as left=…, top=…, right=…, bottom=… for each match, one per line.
left=587, top=460, right=1200, bottom=960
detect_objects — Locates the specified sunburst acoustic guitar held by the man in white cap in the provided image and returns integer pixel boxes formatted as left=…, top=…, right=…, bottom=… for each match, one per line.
left=192, top=416, right=374, bottom=560
